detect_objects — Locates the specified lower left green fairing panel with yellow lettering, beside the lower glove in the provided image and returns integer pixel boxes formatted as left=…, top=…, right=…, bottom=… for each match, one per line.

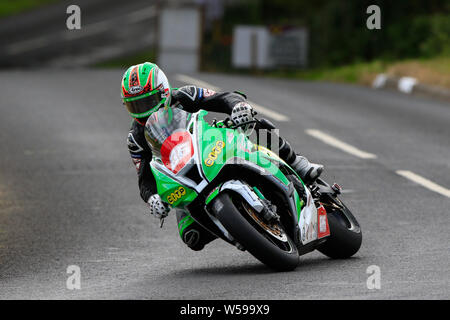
left=150, top=165, right=197, bottom=208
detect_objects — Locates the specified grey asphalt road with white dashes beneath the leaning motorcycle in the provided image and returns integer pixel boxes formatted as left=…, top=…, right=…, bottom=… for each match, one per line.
left=0, top=70, right=450, bottom=299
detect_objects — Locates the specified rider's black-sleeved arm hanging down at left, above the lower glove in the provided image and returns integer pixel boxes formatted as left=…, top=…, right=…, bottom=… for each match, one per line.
left=127, top=121, right=157, bottom=202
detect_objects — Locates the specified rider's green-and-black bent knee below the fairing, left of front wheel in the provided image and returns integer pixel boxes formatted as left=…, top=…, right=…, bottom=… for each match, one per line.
left=176, top=210, right=217, bottom=251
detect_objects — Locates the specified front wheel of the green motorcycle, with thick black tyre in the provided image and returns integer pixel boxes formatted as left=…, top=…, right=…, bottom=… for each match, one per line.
left=212, top=193, right=299, bottom=271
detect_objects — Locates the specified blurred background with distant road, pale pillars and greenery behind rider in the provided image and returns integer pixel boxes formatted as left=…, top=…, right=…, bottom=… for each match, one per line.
left=0, top=0, right=450, bottom=88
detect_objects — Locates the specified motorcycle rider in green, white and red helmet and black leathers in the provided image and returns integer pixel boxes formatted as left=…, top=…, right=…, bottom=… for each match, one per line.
left=121, top=62, right=323, bottom=251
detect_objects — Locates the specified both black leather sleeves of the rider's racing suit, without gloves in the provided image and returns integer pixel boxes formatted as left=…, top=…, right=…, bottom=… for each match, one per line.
left=127, top=86, right=245, bottom=202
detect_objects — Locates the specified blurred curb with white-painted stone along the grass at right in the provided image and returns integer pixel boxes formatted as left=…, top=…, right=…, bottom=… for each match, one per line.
left=372, top=73, right=450, bottom=101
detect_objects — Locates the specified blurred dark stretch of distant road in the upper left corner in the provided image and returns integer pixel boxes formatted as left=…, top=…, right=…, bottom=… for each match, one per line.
left=0, top=0, right=157, bottom=68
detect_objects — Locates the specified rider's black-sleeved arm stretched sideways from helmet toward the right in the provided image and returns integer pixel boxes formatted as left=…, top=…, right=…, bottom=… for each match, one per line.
left=172, top=86, right=246, bottom=114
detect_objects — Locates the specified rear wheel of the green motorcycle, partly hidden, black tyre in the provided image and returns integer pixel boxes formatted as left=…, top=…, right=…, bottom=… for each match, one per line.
left=317, top=196, right=362, bottom=259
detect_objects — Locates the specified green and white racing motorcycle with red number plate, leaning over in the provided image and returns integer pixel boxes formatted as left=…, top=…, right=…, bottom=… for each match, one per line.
left=145, top=108, right=362, bottom=271
